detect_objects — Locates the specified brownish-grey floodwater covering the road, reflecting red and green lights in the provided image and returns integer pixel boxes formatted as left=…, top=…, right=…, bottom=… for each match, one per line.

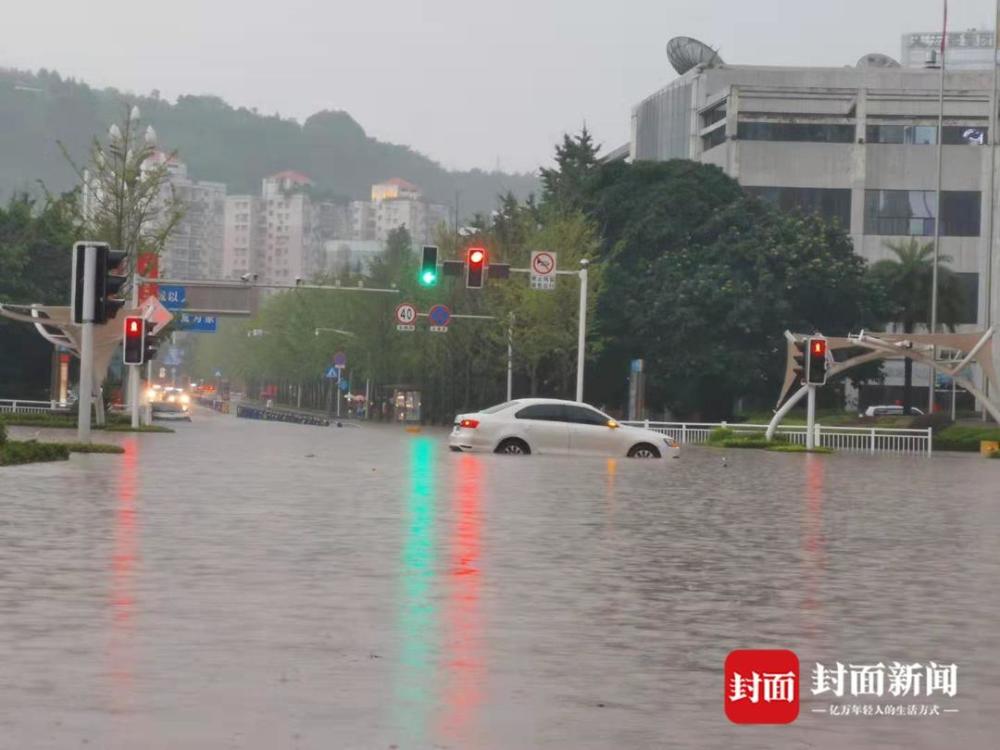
left=0, top=412, right=1000, bottom=750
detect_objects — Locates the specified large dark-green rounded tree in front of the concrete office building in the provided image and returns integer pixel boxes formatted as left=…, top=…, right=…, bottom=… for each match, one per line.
left=592, top=160, right=872, bottom=419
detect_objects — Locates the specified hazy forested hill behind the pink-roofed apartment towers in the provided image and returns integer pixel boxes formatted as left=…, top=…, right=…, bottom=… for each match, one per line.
left=0, top=68, right=539, bottom=217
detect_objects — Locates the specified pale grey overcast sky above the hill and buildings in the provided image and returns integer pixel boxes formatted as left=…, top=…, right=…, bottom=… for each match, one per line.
left=0, top=0, right=994, bottom=170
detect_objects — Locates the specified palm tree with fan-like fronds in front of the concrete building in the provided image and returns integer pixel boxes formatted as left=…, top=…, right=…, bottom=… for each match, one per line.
left=871, top=237, right=965, bottom=414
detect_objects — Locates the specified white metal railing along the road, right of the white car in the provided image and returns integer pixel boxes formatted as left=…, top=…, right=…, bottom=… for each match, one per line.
left=622, top=420, right=934, bottom=455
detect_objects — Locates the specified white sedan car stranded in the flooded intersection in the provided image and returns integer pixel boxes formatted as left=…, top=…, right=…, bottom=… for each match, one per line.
left=448, top=398, right=680, bottom=458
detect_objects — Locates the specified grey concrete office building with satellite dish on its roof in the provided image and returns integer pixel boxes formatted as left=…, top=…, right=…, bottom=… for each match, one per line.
left=629, top=38, right=1000, bottom=402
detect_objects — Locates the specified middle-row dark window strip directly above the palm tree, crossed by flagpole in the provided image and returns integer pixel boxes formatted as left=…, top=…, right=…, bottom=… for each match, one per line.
left=865, top=190, right=980, bottom=237
